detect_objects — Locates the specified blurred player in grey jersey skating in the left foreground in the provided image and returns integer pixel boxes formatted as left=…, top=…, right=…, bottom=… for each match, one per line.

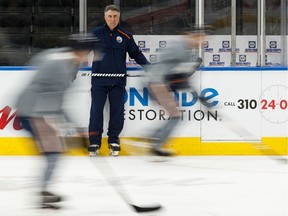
left=16, top=33, right=100, bottom=208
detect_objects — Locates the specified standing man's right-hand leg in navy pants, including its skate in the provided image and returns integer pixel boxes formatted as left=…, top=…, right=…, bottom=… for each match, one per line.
left=107, top=86, right=125, bottom=156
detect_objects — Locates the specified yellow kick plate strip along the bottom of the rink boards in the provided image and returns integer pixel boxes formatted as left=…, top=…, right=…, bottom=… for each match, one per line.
left=0, top=137, right=288, bottom=156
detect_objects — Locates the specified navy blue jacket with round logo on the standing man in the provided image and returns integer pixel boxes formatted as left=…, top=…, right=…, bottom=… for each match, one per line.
left=92, top=24, right=150, bottom=87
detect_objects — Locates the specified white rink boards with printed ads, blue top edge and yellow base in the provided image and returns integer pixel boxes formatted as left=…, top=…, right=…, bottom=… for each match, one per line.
left=0, top=67, right=288, bottom=155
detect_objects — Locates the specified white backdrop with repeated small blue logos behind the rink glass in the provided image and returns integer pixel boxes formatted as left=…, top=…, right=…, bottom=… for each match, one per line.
left=132, top=35, right=283, bottom=67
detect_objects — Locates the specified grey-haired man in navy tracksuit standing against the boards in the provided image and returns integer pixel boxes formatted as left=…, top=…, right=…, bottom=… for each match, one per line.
left=88, top=5, right=149, bottom=156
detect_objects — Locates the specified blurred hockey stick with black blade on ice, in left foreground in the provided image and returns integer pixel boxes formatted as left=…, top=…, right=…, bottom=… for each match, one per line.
left=76, top=133, right=162, bottom=213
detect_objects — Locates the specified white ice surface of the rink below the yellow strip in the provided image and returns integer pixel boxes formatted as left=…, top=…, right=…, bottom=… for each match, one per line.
left=0, top=156, right=288, bottom=216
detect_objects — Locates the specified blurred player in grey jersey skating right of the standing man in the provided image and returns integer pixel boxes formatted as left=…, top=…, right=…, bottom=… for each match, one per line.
left=148, top=28, right=206, bottom=156
